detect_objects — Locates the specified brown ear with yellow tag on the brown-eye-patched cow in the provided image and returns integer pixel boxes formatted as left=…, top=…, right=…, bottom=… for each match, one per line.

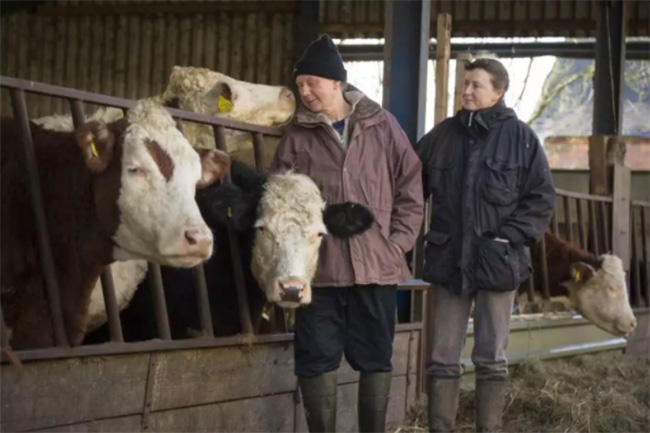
left=75, top=120, right=115, bottom=173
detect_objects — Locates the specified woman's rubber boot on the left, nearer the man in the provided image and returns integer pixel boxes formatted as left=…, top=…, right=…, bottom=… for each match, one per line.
left=427, top=377, right=460, bottom=432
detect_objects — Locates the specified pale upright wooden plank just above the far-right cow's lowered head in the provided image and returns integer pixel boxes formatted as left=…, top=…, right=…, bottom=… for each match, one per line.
left=612, top=164, right=632, bottom=271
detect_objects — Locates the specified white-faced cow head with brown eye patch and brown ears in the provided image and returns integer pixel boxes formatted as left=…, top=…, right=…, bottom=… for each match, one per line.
left=76, top=101, right=230, bottom=267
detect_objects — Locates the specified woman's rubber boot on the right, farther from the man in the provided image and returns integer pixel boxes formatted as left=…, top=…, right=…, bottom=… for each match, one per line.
left=476, top=380, right=506, bottom=432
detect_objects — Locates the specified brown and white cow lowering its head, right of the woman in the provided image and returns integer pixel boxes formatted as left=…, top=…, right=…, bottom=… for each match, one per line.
left=534, top=231, right=636, bottom=336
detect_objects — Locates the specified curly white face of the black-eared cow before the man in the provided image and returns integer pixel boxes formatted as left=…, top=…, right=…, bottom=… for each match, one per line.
left=252, top=174, right=327, bottom=308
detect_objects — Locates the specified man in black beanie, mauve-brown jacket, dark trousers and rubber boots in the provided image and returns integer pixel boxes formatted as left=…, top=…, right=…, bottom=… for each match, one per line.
left=271, top=35, right=423, bottom=432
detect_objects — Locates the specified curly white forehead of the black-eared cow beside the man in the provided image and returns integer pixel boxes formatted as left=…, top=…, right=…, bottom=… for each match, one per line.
left=259, top=172, right=325, bottom=229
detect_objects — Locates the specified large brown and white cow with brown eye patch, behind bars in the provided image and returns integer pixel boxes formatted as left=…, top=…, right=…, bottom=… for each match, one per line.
left=0, top=101, right=230, bottom=349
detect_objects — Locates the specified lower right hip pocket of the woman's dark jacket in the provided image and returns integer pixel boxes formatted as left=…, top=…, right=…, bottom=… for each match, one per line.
left=474, top=237, right=520, bottom=292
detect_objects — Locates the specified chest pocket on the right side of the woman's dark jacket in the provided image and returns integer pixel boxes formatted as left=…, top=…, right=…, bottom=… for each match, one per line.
left=481, top=158, right=519, bottom=206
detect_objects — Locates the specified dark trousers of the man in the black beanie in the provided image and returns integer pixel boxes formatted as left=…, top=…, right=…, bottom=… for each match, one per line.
left=294, top=284, right=397, bottom=377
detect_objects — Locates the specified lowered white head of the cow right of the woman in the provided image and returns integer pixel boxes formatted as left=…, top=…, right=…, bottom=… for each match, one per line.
left=564, top=254, right=636, bottom=336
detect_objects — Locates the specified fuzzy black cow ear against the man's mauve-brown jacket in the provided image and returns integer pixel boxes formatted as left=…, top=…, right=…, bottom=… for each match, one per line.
left=323, top=202, right=375, bottom=239
